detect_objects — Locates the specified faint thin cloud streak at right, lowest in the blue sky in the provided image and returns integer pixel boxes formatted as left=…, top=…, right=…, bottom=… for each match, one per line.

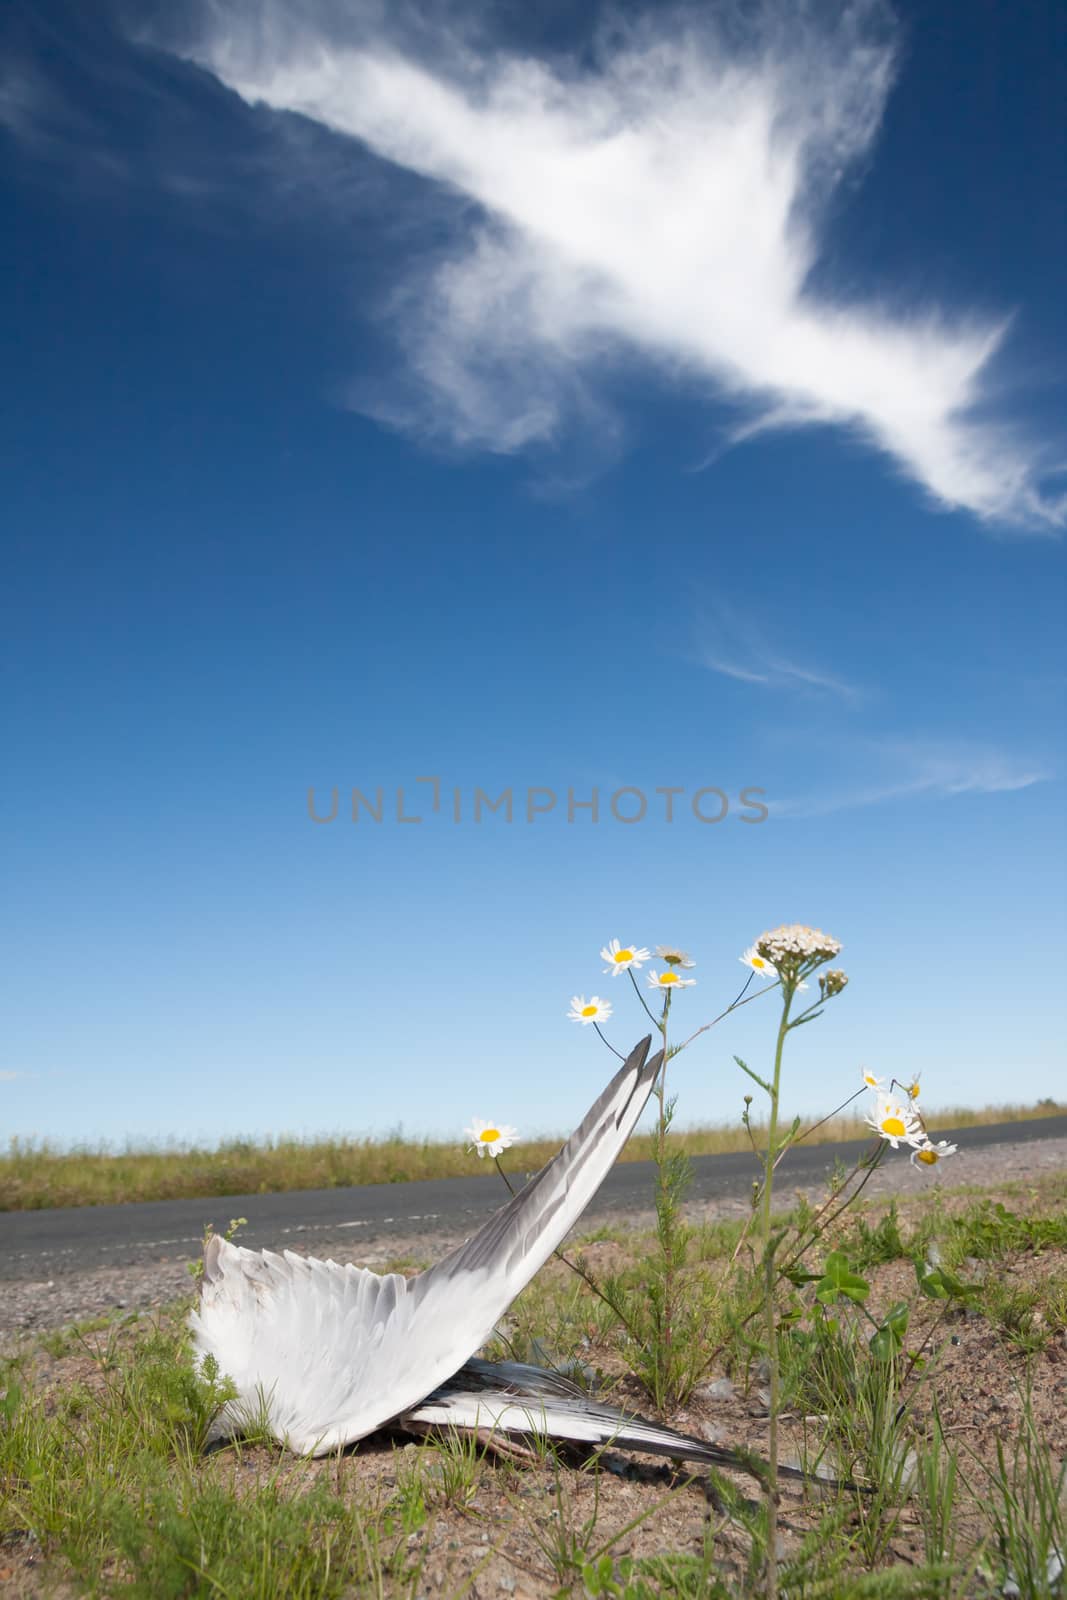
left=771, top=739, right=1051, bottom=818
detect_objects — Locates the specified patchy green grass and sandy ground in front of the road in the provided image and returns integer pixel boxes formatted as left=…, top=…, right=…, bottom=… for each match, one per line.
left=0, top=1174, right=1067, bottom=1600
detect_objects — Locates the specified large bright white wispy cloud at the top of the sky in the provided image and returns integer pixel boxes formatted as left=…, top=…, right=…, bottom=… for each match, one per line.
left=171, top=0, right=1067, bottom=528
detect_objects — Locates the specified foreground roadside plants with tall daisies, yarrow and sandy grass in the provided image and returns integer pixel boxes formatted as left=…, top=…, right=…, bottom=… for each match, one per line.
left=0, top=923, right=1067, bottom=1600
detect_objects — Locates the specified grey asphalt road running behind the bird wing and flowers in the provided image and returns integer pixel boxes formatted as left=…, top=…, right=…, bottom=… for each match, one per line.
left=0, top=1117, right=1067, bottom=1280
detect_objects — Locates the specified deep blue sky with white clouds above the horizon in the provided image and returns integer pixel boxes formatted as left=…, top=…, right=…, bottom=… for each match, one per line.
left=0, top=0, right=1067, bottom=1141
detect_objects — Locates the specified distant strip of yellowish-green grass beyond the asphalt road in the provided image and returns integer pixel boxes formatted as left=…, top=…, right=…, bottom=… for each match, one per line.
left=0, top=1099, right=1067, bottom=1211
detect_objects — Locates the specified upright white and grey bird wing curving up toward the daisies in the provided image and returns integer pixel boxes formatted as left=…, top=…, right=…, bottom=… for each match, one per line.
left=190, top=1038, right=662, bottom=1454
